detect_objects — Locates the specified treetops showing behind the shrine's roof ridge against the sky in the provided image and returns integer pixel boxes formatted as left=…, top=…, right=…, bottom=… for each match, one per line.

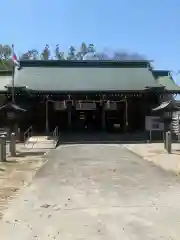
left=0, top=42, right=145, bottom=64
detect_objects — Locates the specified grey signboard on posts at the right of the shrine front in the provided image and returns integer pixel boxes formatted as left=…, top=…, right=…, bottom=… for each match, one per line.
left=145, top=116, right=164, bottom=131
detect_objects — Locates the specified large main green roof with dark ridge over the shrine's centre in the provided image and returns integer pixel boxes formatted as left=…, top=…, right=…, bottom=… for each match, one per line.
left=12, top=61, right=158, bottom=92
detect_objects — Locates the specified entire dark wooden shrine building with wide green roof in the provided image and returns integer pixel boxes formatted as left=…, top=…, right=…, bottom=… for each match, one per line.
left=0, top=60, right=180, bottom=136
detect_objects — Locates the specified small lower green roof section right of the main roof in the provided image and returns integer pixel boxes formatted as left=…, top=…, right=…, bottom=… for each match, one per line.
left=153, top=70, right=180, bottom=92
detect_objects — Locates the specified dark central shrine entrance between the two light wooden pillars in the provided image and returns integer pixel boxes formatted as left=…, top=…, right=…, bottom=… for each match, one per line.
left=48, top=101, right=128, bottom=133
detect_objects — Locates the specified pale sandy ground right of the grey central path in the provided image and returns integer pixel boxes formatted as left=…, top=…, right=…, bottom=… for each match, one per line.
left=123, top=143, right=180, bottom=174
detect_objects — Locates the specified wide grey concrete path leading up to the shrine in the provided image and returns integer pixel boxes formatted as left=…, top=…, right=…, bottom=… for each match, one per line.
left=0, top=144, right=180, bottom=240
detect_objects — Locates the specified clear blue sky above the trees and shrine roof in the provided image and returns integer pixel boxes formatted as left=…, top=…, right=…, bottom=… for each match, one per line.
left=0, top=0, right=180, bottom=78
